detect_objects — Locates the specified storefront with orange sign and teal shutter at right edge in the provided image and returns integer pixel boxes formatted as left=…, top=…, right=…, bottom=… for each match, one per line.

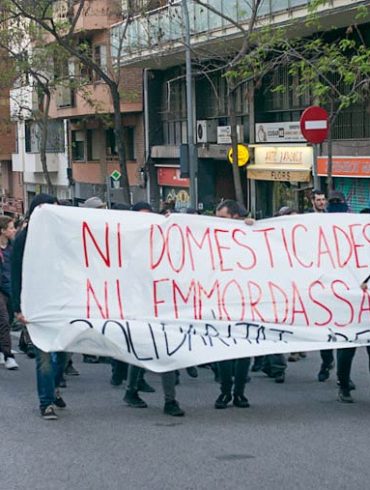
left=317, top=156, right=370, bottom=213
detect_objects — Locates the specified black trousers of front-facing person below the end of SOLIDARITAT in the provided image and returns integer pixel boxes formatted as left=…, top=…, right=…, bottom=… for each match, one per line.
left=218, top=357, right=251, bottom=395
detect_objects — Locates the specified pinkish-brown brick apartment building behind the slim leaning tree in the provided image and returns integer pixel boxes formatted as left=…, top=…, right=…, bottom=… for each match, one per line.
left=50, top=0, right=146, bottom=202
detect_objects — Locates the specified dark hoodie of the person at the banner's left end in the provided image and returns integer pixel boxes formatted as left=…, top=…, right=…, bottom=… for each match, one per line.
left=12, top=194, right=58, bottom=313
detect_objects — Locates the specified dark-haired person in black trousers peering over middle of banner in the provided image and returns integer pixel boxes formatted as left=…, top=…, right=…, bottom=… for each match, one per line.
left=215, top=199, right=250, bottom=409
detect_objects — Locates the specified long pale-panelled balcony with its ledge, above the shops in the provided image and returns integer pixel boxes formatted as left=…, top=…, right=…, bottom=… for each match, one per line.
left=111, top=0, right=363, bottom=68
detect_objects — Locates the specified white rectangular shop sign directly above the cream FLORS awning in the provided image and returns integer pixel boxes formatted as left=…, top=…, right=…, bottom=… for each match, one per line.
left=256, top=121, right=305, bottom=143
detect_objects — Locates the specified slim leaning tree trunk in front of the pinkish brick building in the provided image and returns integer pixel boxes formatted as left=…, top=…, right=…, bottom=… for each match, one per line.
left=109, top=83, right=131, bottom=204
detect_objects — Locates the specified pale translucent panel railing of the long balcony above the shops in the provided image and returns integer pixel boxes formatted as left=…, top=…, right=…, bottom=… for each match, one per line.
left=111, top=0, right=364, bottom=65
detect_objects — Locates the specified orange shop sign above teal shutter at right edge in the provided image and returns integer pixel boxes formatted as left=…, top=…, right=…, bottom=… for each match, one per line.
left=317, top=157, right=370, bottom=178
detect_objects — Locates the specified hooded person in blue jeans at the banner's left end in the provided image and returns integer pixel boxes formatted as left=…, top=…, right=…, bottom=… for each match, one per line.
left=11, top=194, right=66, bottom=420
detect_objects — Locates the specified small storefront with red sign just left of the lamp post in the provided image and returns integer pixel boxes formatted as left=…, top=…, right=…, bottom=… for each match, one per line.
left=157, top=166, right=190, bottom=211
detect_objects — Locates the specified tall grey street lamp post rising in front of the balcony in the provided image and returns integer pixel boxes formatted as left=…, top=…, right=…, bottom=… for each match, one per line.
left=182, top=0, right=198, bottom=209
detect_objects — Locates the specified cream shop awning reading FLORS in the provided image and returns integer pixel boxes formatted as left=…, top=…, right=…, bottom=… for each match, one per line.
left=247, top=145, right=313, bottom=182
